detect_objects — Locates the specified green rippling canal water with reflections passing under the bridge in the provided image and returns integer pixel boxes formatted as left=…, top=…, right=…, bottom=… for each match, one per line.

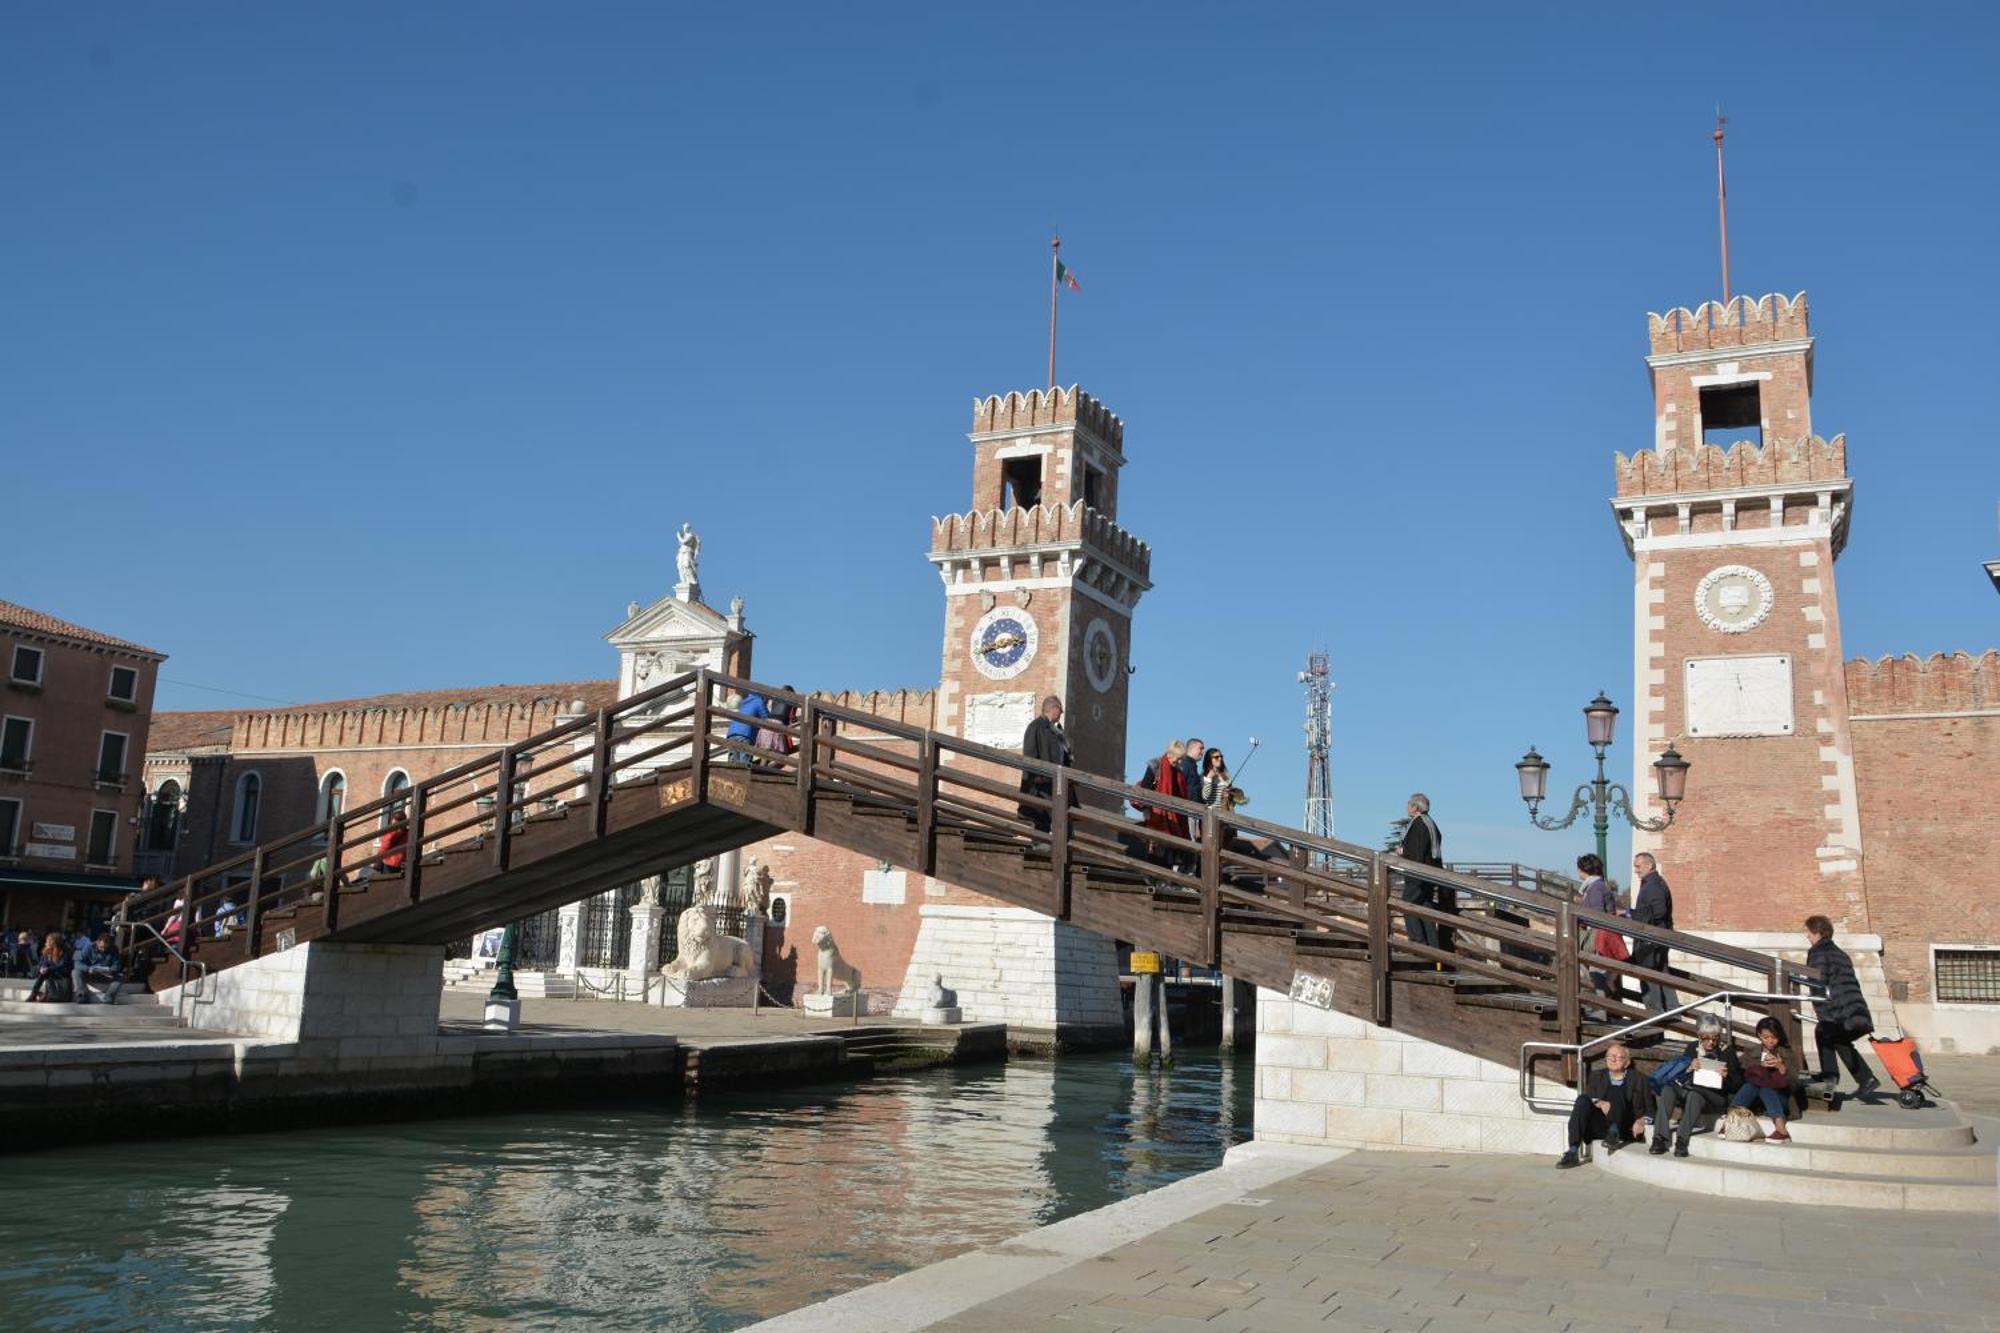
left=0, top=1049, right=1252, bottom=1331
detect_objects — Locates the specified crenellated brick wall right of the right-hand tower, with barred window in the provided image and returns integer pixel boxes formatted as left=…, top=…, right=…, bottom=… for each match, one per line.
left=1846, top=652, right=2000, bottom=1001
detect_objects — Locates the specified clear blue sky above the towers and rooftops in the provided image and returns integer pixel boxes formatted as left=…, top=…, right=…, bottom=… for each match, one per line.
left=0, top=4, right=2000, bottom=865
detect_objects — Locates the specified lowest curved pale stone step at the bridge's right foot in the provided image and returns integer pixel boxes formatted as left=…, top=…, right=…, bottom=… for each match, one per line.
left=1594, top=1135, right=2000, bottom=1213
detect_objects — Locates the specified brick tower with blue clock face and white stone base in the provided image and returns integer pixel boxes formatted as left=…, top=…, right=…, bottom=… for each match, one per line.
left=898, top=386, right=1152, bottom=1043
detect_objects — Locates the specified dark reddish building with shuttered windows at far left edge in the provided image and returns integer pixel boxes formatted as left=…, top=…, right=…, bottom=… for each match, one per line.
left=0, top=602, right=166, bottom=931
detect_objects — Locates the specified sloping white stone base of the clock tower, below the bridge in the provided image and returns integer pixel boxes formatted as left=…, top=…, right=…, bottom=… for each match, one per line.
left=894, top=905, right=1124, bottom=1029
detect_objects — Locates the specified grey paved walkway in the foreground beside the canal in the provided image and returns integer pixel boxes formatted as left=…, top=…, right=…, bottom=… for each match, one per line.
left=930, top=1153, right=2000, bottom=1333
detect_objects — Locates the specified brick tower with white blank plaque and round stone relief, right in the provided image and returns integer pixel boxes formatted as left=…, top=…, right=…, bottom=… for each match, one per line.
left=1612, top=292, right=1880, bottom=932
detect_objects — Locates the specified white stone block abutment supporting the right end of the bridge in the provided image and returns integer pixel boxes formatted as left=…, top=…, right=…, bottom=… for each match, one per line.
left=1254, top=989, right=1564, bottom=1153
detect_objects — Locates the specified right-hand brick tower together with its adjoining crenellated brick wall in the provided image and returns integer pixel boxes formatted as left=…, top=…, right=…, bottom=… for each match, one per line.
left=1612, top=292, right=2000, bottom=1049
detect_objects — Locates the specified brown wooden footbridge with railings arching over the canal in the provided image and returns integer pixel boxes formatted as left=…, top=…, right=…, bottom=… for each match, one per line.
left=126, top=671, right=1810, bottom=1065
